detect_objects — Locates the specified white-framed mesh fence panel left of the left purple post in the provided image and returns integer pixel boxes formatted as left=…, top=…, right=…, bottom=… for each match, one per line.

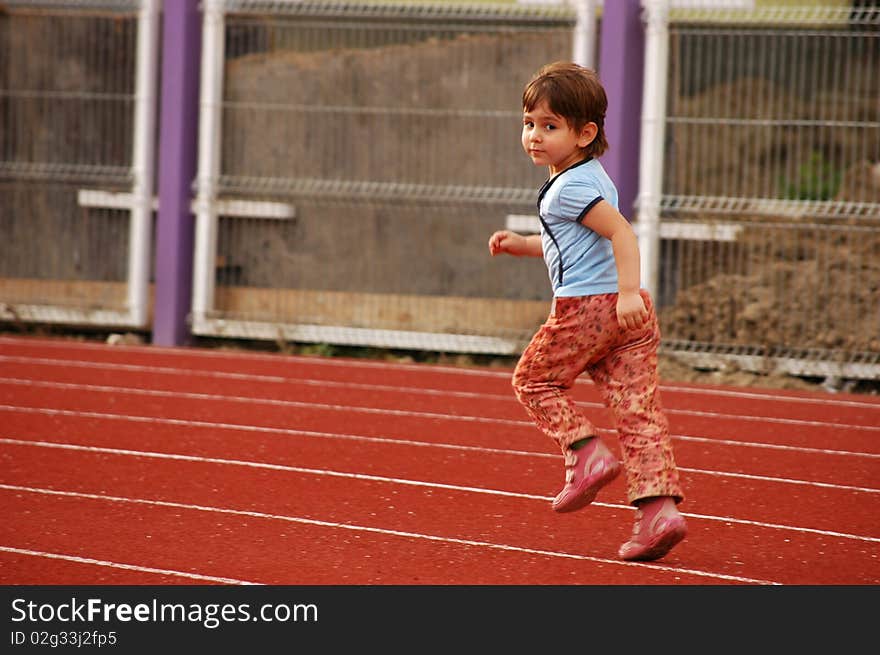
left=0, top=0, right=159, bottom=328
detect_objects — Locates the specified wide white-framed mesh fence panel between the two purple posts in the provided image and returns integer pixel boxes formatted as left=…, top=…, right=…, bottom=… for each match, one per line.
left=193, top=0, right=595, bottom=353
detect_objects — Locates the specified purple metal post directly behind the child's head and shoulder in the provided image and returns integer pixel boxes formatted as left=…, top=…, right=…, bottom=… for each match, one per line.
left=598, top=0, right=645, bottom=222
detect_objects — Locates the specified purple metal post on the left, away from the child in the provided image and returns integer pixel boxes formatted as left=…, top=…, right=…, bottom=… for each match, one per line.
left=153, top=0, right=202, bottom=346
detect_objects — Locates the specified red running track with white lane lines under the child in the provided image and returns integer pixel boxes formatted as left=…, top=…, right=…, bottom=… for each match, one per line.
left=0, top=338, right=880, bottom=585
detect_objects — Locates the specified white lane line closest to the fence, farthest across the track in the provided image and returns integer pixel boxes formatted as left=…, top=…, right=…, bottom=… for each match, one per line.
left=0, top=336, right=880, bottom=409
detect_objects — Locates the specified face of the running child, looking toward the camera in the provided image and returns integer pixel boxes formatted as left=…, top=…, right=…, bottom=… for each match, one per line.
left=522, top=100, right=598, bottom=175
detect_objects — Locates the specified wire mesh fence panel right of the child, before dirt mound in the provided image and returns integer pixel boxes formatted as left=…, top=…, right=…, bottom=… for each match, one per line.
left=660, top=3, right=880, bottom=377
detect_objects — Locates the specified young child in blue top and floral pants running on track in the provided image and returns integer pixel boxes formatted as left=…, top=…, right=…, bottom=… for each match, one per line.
left=489, top=62, right=687, bottom=560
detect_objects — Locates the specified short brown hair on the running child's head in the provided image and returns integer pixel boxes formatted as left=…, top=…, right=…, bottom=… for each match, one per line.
left=523, top=61, right=608, bottom=157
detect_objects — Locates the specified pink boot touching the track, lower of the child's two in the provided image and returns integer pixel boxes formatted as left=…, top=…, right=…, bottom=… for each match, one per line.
left=618, top=496, right=687, bottom=561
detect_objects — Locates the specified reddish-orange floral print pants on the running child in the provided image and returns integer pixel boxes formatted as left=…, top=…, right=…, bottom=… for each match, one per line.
left=513, top=290, right=684, bottom=504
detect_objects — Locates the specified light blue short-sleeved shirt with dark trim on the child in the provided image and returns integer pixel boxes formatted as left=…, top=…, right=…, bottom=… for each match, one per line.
left=538, top=158, right=618, bottom=297
